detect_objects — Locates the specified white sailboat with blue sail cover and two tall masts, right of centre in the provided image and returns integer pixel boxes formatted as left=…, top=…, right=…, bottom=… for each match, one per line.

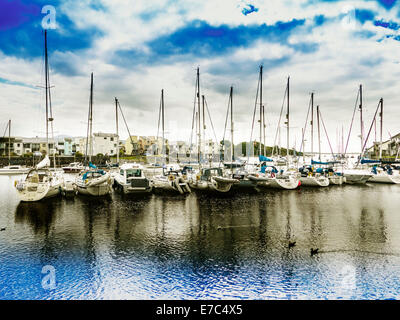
left=248, top=72, right=300, bottom=190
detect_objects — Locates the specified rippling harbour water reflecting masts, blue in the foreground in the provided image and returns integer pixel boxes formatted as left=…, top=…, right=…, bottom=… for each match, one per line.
left=0, top=176, right=400, bottom=299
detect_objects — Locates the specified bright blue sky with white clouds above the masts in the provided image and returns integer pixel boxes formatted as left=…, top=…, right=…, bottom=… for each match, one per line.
left=0, top=0, right=400, bottom=151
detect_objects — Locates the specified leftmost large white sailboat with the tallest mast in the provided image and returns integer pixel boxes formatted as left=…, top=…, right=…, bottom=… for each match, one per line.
left=15, top=30, right=62, bottom=202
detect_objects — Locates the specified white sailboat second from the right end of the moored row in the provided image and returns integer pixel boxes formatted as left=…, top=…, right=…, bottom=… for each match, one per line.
left=338, top=84, right=372, bottom=184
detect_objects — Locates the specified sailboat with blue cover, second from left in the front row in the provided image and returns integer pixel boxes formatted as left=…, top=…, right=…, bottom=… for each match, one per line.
left=75, top=73, right=113, bottom=196
